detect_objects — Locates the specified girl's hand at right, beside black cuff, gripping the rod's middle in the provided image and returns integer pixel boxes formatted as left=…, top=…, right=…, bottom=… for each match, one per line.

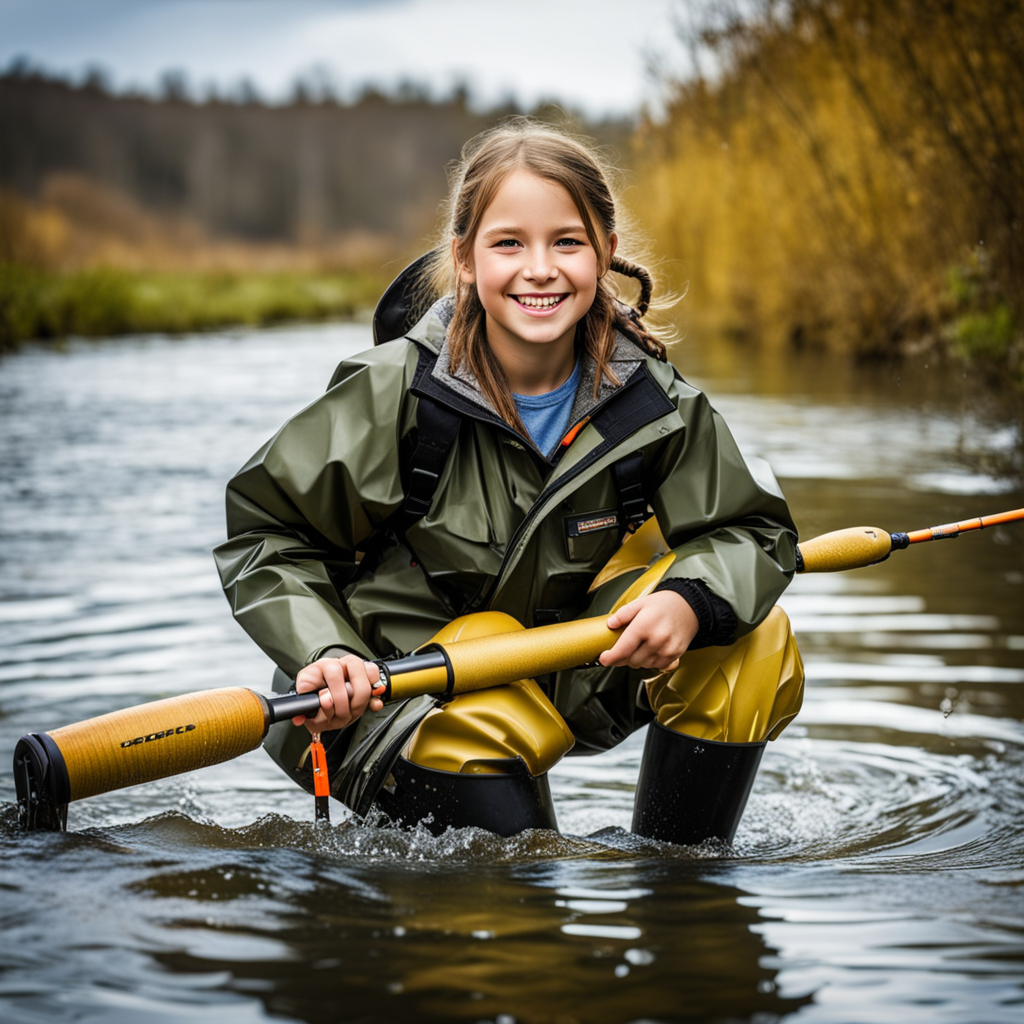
left=599, top=590, right=699, bottom=672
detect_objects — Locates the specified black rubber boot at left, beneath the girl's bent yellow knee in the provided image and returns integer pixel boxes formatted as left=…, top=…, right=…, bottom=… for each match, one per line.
left=375, top=758, right=558, bottom=836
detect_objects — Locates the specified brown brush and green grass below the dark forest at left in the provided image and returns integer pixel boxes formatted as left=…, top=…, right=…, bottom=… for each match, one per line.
left=0, top=175, right=397, bottom=350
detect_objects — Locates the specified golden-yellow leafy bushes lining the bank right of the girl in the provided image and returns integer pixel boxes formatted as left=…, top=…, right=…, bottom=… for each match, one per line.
left=636, top=0, right=1024, bottom=380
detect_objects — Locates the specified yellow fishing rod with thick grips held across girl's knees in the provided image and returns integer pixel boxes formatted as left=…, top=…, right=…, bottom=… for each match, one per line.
left=14, top=509, right=1024, bottom=829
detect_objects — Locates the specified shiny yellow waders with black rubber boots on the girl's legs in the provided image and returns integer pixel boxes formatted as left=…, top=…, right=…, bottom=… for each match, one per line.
left=387, top=520, right=804, bottom=843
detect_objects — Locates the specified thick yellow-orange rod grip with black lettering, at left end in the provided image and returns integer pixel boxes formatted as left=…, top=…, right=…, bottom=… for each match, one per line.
left=49, top=687, right=267, bottom=800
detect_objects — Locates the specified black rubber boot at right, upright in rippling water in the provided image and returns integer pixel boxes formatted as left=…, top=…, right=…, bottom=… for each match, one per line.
left=633, top=722, right=765, bottom=846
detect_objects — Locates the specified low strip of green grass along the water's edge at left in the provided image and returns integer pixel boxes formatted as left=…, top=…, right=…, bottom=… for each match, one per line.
left=0, top=263, right=386, bottom=351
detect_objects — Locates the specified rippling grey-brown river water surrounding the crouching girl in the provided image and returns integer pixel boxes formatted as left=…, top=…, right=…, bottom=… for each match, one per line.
left=0, top=325, right=1024, bottom=1024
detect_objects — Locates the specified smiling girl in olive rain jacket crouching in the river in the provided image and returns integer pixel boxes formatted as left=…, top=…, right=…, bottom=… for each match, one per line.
left=216, top=122, right=800, bottom=842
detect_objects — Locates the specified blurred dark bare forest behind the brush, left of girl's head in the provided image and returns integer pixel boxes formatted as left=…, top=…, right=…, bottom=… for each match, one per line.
left=0, top=67, right=630, bottom=265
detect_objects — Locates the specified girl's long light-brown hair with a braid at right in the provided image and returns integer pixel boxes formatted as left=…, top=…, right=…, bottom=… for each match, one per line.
left=430, top=118, right=667, bottom=433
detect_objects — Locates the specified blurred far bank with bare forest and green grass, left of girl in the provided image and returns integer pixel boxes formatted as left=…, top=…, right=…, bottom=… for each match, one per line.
left=0, top=63, right=632, bottom=350
